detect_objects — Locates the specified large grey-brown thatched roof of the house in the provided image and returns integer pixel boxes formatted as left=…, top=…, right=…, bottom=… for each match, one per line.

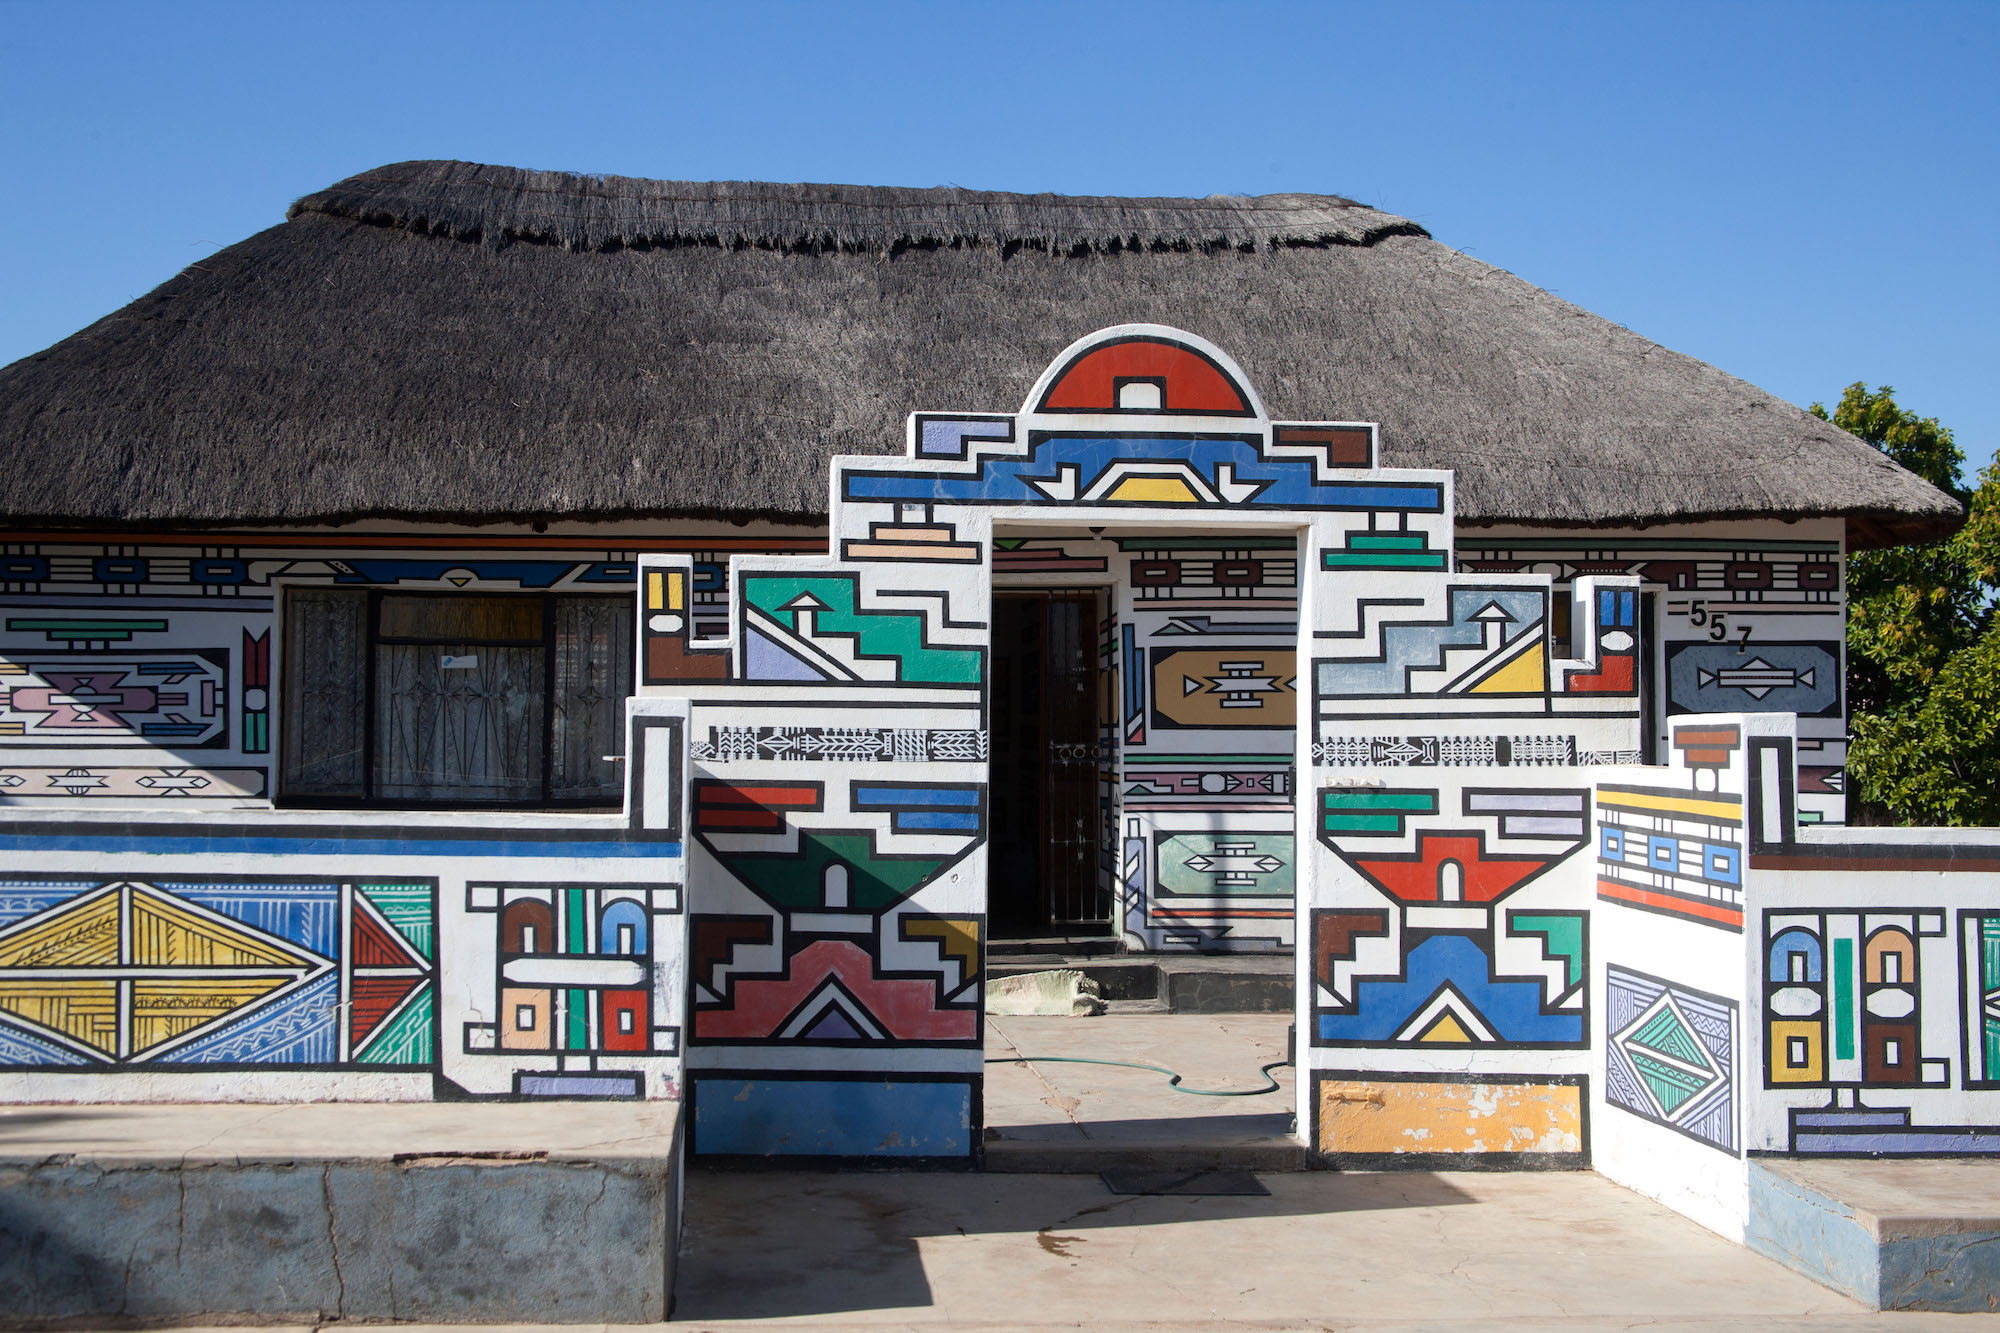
left=0, top=162, right=1960, bottom=544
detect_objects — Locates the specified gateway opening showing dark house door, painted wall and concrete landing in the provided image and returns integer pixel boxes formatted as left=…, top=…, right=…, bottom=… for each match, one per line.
left=982, top=556, right=1302, bottom=1171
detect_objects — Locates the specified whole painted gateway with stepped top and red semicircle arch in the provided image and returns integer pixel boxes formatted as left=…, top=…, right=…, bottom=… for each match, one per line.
left=640, top=324, right=1638, bottom=1161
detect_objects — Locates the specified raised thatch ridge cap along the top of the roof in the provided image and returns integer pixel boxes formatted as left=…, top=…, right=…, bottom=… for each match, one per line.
left=286, top=162, right=1428, bottom=252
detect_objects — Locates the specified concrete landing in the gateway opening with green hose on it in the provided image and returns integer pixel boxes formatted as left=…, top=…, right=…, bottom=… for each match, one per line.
left=986, top=1011, right=1308, bottom=1173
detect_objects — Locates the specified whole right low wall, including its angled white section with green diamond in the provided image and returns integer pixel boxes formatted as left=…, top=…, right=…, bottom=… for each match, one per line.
left=1592, top=715, right=2000, bottom=1239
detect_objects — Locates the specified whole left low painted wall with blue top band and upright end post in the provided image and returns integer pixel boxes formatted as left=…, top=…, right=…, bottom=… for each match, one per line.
left=0, top=701, right=686, bottom=1101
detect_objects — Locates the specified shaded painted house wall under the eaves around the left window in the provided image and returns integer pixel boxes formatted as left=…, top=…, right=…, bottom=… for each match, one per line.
left=0, top=522, right=824, bottom=811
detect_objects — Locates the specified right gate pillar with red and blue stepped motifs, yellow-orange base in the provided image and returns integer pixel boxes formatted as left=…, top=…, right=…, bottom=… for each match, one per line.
left=1298, top=550, right=1642, bottom=1167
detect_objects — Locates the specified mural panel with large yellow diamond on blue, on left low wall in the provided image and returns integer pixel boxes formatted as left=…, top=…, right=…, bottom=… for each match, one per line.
left=0, top=877, right=438, bottom=1069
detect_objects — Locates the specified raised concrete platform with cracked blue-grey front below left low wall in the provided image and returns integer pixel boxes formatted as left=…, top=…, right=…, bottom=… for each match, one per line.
left=0, top=1103, right=680, bottom=1323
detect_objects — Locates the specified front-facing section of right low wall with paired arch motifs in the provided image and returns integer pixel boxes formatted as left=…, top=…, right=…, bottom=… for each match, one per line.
left=1744, top=789, right=2000, bottom=1157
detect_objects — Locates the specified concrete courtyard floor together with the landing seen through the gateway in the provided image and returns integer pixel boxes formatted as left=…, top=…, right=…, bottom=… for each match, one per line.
left=58, top=1013, right=2000, bottom=1333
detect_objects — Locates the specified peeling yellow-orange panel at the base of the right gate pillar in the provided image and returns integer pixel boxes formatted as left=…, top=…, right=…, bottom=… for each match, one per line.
left=1318, top=1079, right=1584, bottom=1153
